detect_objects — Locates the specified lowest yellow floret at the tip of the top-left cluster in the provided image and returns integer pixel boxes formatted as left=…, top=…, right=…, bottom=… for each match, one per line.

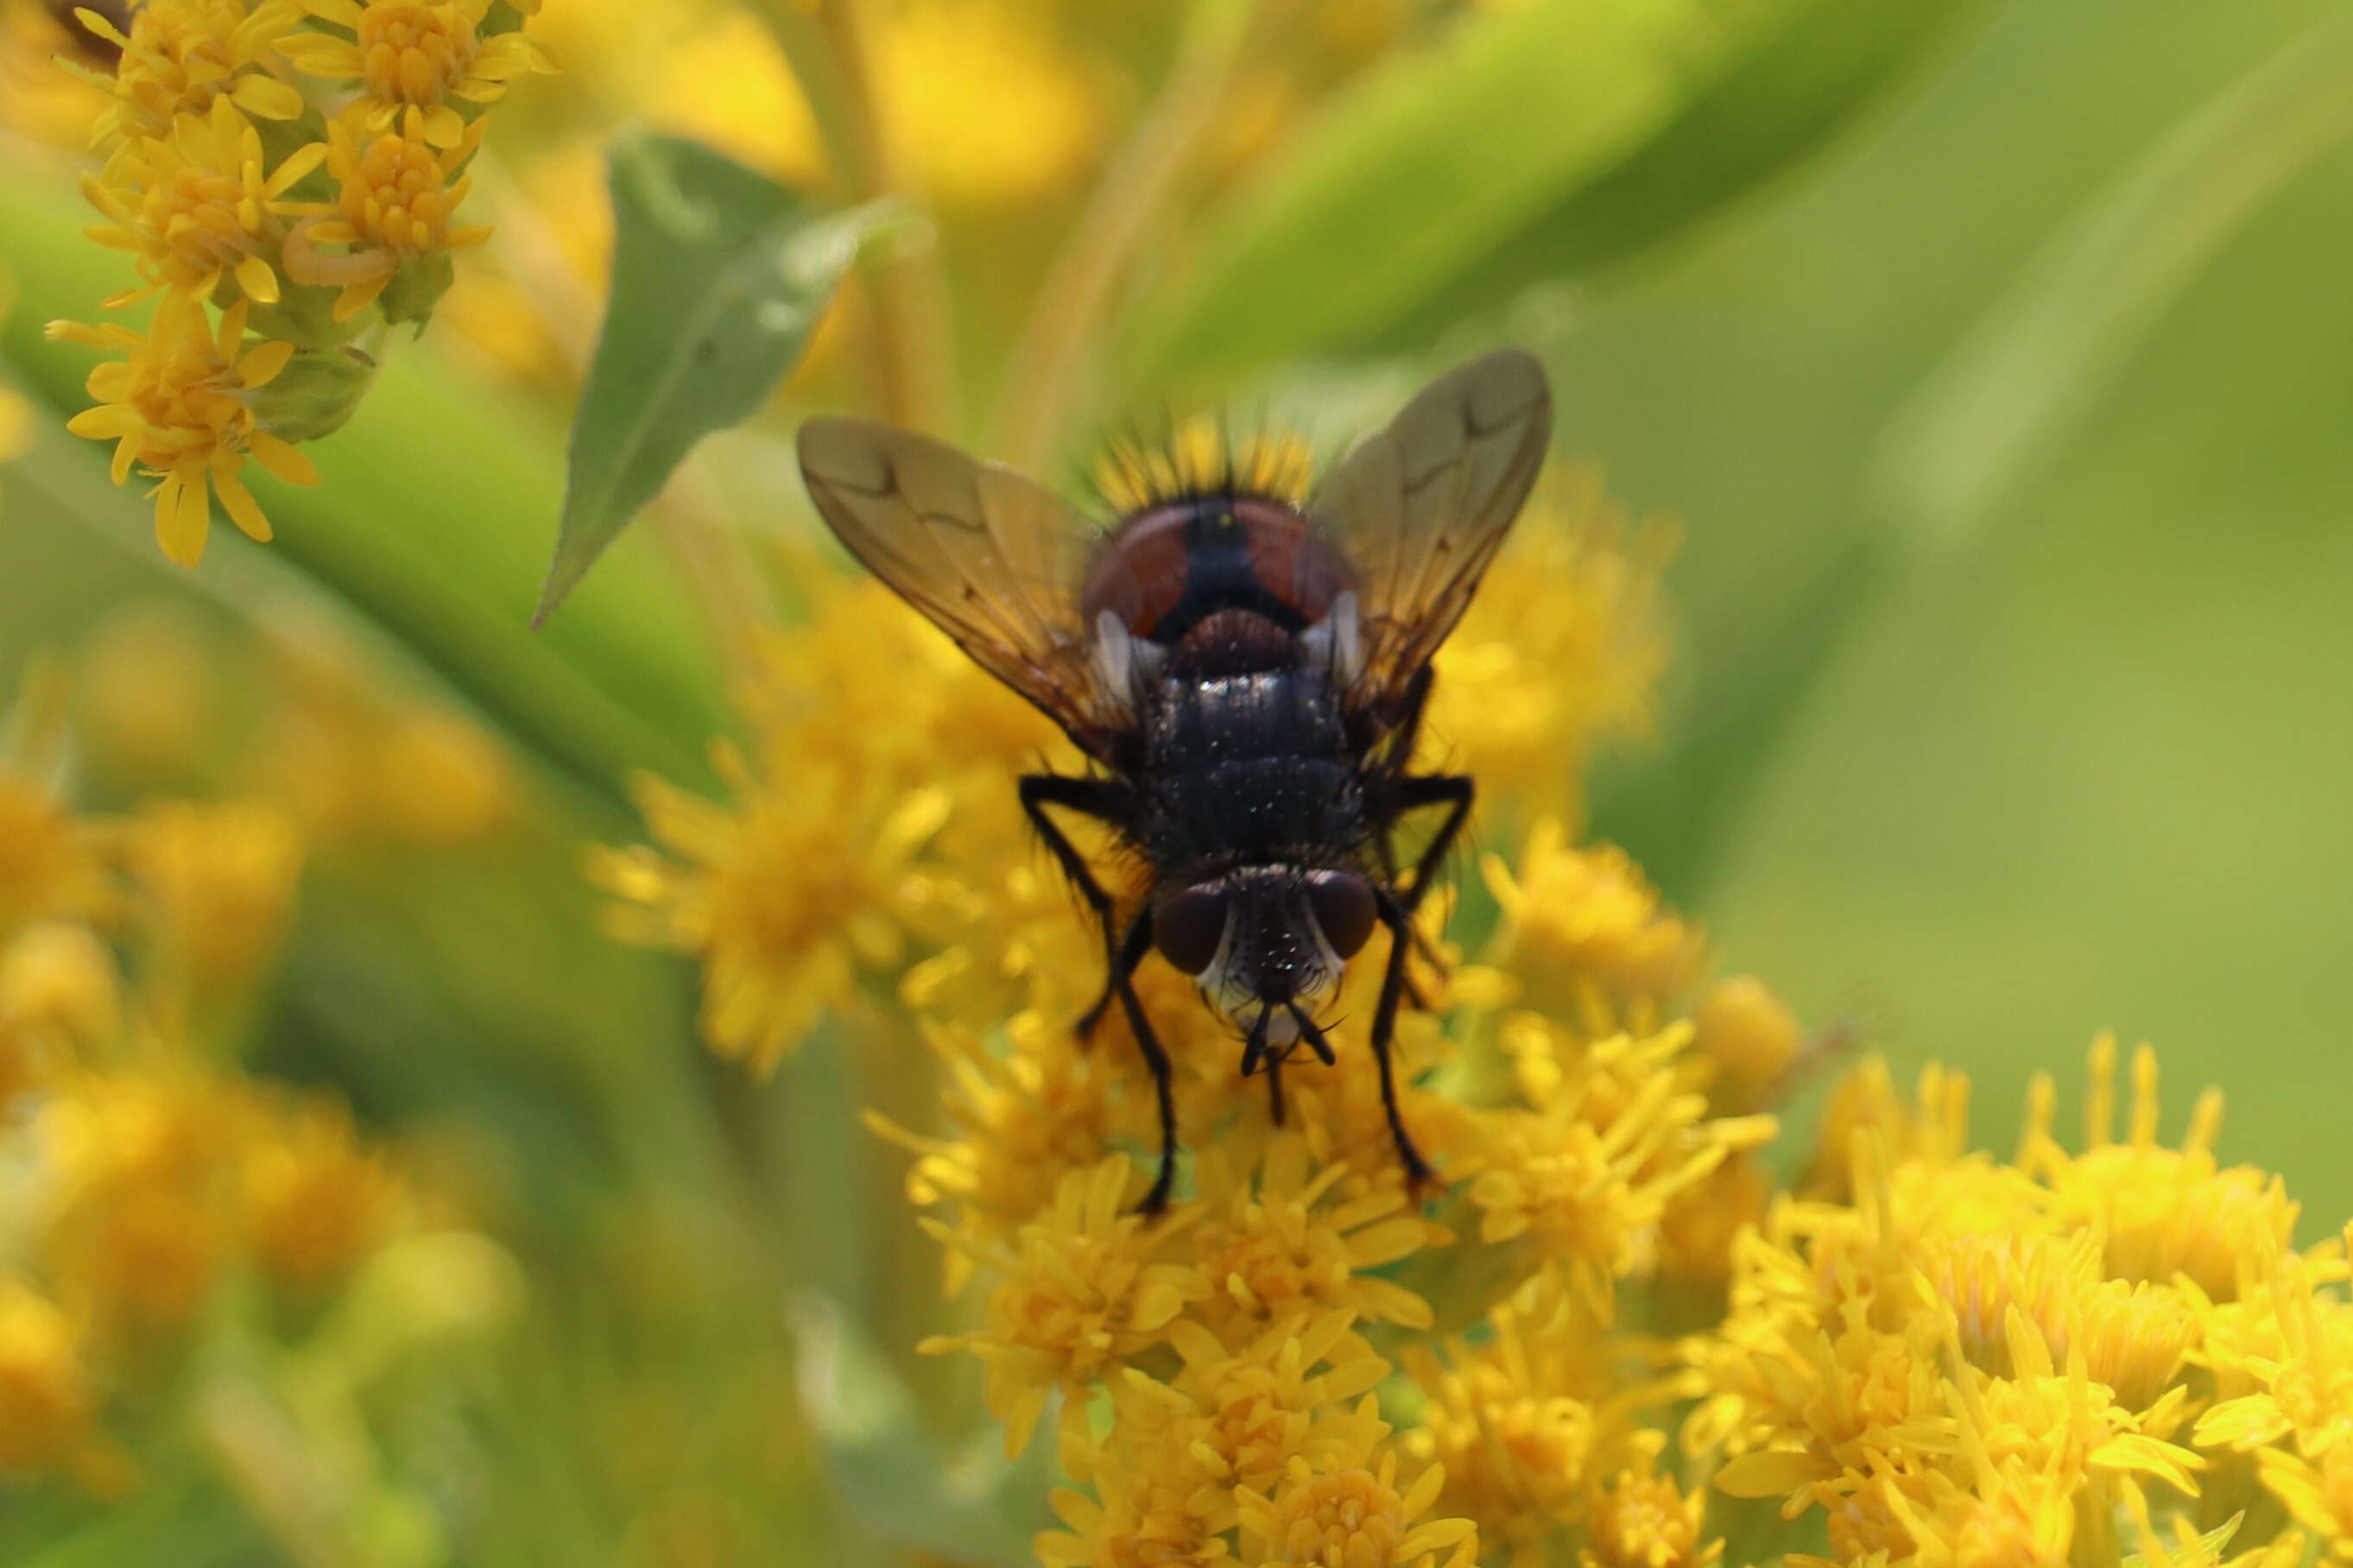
left=49, top=299, right=318, bottom=567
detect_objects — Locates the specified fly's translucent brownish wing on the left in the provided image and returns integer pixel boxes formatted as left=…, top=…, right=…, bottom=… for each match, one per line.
left=800, top=419, right=1123, bottom=754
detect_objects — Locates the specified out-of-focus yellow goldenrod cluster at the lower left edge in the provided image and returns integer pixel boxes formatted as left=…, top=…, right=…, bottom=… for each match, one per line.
left=0, top=654, right=513, bottom=1497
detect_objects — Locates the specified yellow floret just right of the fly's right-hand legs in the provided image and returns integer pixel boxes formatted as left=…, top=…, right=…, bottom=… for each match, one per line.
left=1480, top=817, right=1706, bottom=1017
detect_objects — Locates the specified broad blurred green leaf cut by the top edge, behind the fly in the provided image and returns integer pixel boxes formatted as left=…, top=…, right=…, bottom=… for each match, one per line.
left=1123, top=0, right=1977, bottom=386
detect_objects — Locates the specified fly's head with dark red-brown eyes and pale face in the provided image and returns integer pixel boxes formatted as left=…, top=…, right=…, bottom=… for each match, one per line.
left=1153, top=866, right=1379, bottom=1073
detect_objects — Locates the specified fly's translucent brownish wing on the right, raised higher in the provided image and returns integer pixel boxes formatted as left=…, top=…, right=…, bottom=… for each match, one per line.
left=1308, top=349, right=1553, bottom=718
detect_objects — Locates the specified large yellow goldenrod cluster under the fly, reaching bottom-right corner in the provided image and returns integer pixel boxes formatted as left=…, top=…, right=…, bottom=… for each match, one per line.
left=593, top=433, right=2353, bottom=1568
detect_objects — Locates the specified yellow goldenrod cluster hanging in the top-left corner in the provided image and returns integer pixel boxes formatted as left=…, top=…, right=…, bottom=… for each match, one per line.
left=52, top=0, right=548, bottom=565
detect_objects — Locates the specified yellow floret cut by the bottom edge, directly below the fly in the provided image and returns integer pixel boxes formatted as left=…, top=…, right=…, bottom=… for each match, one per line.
left=1236, top=1394, right=1477, bottom=1568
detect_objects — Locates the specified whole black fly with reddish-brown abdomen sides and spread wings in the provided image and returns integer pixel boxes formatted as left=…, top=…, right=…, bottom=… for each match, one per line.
left=800, top=351, right=1553, bottom=1211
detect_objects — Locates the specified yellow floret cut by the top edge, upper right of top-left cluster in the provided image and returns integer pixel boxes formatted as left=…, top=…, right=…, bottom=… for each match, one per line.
left=278, top=0, right=551, bottom=149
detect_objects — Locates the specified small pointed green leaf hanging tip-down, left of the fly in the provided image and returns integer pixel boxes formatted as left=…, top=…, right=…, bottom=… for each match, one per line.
left=532, top=132, right=876, bottom=624
